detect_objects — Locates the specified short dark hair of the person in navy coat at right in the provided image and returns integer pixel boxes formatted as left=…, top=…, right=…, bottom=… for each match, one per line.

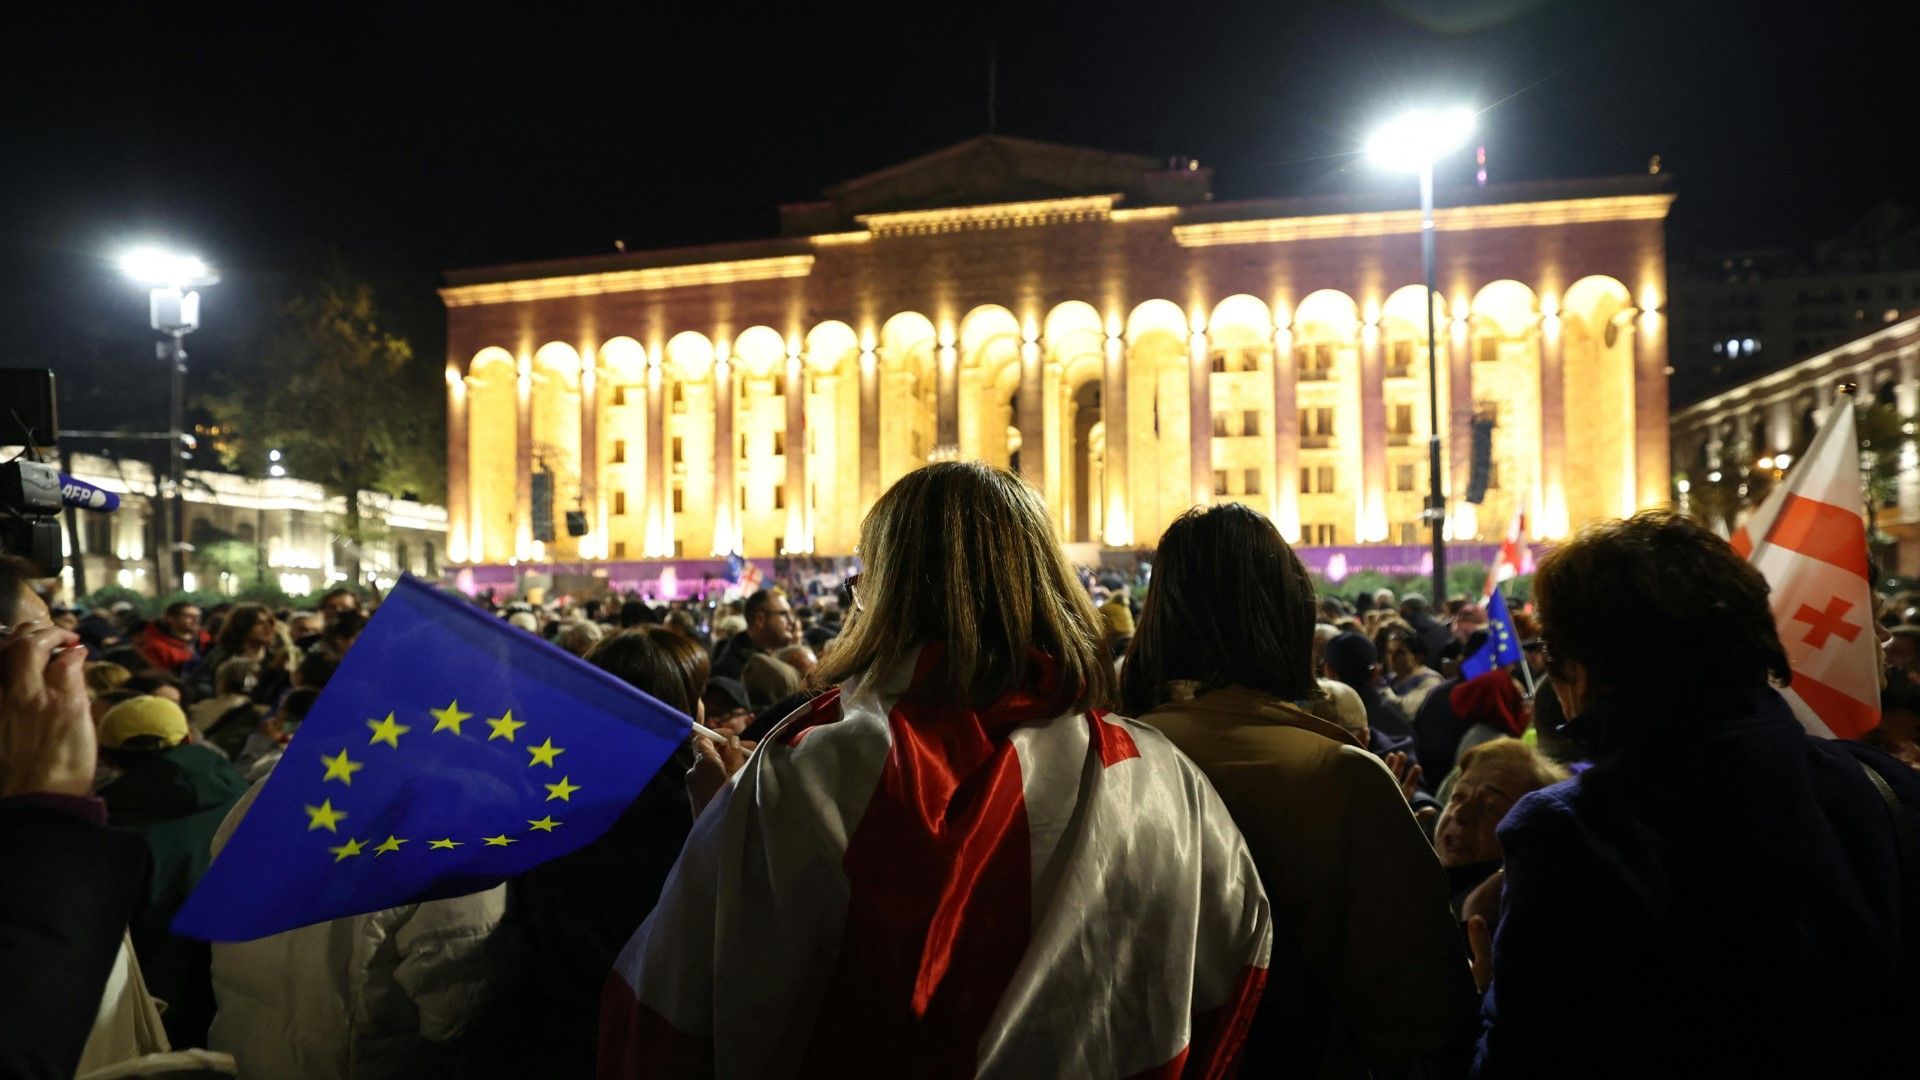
left=1534, top=509, right=1793, bottom=713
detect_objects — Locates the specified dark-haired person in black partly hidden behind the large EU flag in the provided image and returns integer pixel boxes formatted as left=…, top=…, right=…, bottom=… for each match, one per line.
left=459, top=625, right=708, bottom=1076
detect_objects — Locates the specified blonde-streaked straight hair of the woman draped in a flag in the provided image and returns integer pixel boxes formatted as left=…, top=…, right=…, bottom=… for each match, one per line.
left=808, top=461, right=1116, bottom=709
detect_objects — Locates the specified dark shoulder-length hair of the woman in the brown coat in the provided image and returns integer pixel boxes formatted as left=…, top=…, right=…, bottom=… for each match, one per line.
left=1119, top=503, right=1317, bottom=717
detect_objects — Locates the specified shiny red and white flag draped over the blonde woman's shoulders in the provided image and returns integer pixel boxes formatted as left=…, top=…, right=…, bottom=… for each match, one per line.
left=599, top=646, right=1271, bottom=1078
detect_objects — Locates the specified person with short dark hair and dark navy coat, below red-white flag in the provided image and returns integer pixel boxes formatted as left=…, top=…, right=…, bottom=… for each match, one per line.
left=1471, top=511, right=1920, bottom=1076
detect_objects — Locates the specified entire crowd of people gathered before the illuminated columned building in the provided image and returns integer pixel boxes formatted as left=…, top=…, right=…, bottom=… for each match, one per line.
left=0, top=463, right=1920, bottom=1078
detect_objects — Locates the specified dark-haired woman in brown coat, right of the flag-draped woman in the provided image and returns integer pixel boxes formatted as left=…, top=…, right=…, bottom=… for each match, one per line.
left=1121, top=503, right=1473, bottom=1076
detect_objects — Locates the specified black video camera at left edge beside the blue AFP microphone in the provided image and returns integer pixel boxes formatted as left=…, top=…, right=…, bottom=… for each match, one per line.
left=0, top=367, right=63, bottom=577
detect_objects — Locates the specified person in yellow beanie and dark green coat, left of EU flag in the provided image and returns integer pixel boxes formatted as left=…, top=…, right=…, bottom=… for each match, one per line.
left=100, top=694, right=246, bottom=1047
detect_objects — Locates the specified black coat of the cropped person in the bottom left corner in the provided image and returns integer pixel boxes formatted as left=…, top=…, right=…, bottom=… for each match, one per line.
left=0, top=796, right=148, bottom=1080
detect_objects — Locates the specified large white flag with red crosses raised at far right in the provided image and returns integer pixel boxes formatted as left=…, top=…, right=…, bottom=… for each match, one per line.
left=1734, top=396, right=1880, bottom=738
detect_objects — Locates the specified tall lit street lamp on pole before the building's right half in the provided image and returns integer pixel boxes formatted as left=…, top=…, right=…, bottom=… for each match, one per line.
left=1367, top=106, right=1473, bottom=605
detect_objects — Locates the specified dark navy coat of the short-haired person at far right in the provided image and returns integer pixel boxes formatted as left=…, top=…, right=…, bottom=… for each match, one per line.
left=1476, top=690, right=1920, bottom=1078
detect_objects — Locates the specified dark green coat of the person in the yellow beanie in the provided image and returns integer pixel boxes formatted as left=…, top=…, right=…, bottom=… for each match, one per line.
left=100, top=746, right=248, bottom=1047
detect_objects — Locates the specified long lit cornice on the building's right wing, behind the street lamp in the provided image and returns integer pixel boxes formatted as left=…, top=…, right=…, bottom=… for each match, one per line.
left=1173, top=192, right=1674, bottom=248
